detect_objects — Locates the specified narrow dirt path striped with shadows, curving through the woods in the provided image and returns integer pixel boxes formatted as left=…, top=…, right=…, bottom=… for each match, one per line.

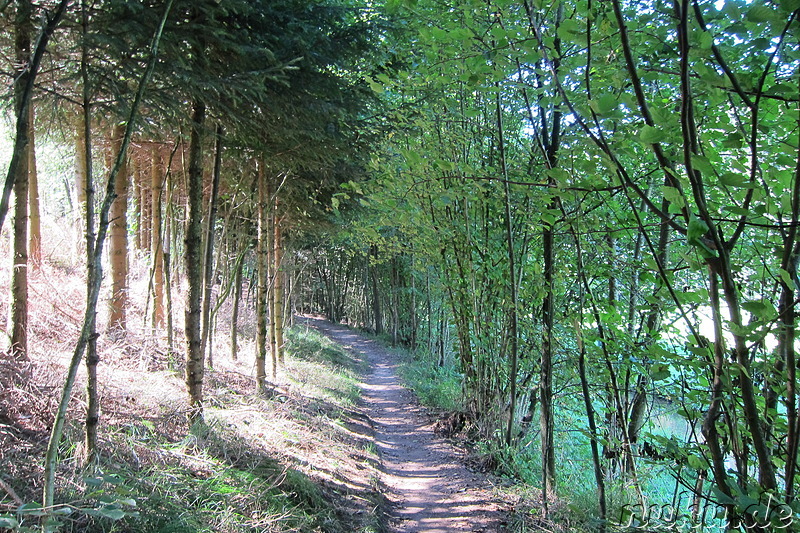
left=306, top=318, right=505, bottom=533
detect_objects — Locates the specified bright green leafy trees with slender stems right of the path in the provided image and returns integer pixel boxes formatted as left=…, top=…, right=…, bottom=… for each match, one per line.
left=298, top=0, right=800, bottom=529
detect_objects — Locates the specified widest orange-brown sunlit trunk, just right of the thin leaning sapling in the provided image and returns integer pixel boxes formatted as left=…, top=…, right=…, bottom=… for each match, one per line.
left=108, top=124, right=129, bottom=335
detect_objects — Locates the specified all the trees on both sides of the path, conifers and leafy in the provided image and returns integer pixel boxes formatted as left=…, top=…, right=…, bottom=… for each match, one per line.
left=0, top=0, right=800, bottom=531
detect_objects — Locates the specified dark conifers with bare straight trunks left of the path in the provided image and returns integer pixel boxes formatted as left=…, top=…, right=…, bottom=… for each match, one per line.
left=0, top=0, right=383, bottom=507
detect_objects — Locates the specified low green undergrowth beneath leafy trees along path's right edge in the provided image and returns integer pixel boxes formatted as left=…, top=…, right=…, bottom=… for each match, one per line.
left=401, top=352, right=692, bottom=533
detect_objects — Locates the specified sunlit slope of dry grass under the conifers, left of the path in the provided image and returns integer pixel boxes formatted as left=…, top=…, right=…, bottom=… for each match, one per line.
left=0, top=227, right=381, bottom=532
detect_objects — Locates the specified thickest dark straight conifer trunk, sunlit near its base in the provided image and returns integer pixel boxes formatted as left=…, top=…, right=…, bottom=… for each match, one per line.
left=185, top=99, right=206, bottom=422
